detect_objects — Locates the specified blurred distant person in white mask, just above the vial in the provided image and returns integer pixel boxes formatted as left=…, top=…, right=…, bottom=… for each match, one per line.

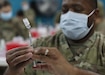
left=22, top=0, right=36, bottom=27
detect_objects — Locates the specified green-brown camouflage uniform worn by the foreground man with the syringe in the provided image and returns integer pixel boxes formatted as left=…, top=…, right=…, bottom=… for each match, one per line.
left=25, top=32, right=105, bottom=75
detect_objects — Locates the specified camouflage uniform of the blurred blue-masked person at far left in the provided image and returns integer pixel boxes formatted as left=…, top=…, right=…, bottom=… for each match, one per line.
left=0, top=21, right=16, bottom=41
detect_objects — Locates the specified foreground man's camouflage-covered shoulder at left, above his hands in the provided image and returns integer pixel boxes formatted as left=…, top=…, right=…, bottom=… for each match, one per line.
left=34, top=31, right=64, bottom=47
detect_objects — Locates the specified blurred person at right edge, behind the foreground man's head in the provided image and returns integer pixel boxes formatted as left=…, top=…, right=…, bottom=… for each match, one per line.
left=96, top=0, right=105, bottom=35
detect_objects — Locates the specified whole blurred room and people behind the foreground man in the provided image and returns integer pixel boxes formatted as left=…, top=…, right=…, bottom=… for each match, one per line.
left=0, top=0, right=105, bottom=75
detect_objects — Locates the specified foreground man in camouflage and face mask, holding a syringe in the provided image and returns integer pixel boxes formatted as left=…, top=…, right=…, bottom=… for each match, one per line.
left=5, top=0, right=105, bottom=75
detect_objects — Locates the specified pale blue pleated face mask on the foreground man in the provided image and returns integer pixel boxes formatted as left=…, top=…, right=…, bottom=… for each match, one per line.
left=60, top=10, right=95, bottom=40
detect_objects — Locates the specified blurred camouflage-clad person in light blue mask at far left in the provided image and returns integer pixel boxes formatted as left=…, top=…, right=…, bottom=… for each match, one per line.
left=0, top=1, right=15, bottom=41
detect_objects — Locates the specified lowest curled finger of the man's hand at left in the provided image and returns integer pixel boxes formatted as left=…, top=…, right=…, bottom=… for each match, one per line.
left=11, top=53, right=33, bottom=66
